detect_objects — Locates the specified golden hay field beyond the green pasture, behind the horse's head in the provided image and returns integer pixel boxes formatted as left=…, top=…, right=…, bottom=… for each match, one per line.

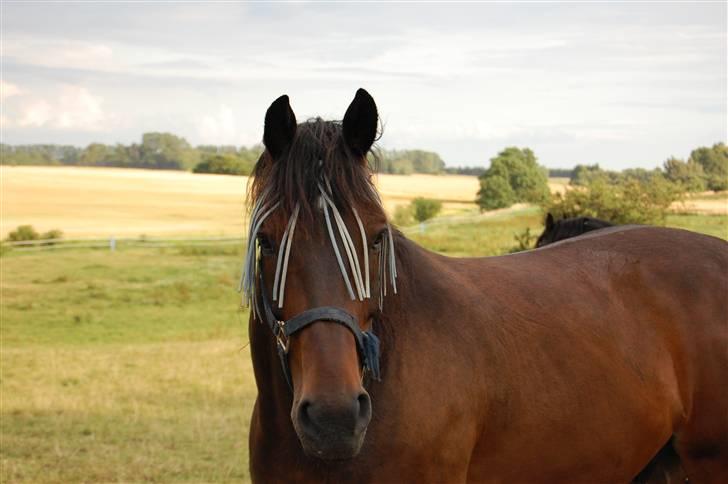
left=0, top=166, right=478, bottom=237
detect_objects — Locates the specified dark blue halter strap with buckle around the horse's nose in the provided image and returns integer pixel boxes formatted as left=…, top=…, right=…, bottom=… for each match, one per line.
left=255, top=263, right=381, bottom=390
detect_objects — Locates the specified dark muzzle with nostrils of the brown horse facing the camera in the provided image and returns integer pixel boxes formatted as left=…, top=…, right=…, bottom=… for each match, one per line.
left=291, top=389, right=372, bottom=460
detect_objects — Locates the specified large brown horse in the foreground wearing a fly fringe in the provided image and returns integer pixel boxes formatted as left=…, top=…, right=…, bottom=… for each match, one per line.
left=242, top=90, right=728, bottom=483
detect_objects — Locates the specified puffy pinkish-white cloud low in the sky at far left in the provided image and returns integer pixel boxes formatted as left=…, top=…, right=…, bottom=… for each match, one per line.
left=18, top=86, right=107, bottom=131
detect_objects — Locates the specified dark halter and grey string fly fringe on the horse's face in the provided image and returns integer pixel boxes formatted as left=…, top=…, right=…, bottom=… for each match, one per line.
left=238, top=170, right=397, bottom=389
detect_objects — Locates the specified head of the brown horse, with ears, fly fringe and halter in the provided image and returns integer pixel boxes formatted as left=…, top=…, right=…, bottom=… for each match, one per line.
left=241, top=89, right=396, bottom=459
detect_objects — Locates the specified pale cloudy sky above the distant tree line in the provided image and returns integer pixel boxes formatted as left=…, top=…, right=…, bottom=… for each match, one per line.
left=0, top=0, right=728, bottom=169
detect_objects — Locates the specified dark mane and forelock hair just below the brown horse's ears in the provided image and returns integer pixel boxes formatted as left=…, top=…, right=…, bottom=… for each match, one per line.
left=248, top=117, right=384, bottom=226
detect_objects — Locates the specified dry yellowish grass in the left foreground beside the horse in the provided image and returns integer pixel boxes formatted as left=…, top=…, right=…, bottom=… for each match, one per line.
left=1, top=339, right=255, bottom=482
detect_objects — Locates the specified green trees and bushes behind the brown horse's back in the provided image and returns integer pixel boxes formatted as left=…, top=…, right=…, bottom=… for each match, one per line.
left=476, top=143, right=728, bottom=224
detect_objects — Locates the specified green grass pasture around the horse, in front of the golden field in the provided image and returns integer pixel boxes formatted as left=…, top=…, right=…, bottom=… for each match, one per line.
left=0, top=214, right=728, bottom=483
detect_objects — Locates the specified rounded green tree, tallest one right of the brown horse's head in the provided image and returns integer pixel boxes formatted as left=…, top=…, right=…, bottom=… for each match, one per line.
left=477, top=147, right=549, bottom=210
